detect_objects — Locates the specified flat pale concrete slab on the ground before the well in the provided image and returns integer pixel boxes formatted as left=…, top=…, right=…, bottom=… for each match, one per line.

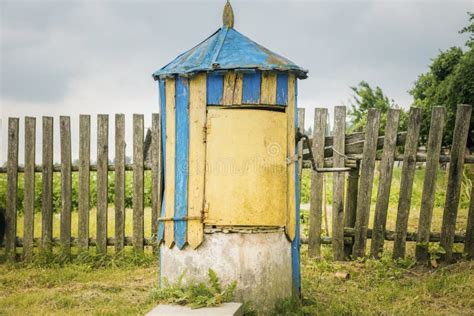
left=146, top=303, right=244, bottom=316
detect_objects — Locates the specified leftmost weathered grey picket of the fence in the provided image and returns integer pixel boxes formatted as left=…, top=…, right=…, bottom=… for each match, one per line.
left=5, top=117, right=20, bottom=259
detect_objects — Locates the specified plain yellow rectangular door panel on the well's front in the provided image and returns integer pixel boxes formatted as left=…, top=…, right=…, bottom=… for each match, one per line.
left=205, top=108, right=286, bottom=227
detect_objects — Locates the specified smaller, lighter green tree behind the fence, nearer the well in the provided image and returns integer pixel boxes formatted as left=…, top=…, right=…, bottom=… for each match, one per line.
left=349, top=81, right=407, bottom=135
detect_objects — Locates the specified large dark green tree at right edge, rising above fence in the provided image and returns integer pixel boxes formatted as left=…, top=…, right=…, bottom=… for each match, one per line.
left=409, top=13, right=474, bottom=146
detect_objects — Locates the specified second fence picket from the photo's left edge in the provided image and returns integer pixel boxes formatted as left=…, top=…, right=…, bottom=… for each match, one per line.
left=23, top=117, right=36, bottom=259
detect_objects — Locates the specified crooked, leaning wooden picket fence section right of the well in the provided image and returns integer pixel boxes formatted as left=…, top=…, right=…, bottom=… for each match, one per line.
left=299, top=105, right=474, bottom=262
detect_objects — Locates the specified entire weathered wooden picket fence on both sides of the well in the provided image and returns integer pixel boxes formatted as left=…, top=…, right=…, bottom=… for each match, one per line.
left=0, top=105, right=474, bottom=261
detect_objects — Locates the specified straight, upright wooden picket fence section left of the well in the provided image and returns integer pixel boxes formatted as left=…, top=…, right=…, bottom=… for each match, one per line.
left=0, top=114, right=162, bottom=257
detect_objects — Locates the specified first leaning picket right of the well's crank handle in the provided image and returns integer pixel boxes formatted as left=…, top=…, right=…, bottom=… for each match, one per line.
left=352, top=109, right=380, bottom=258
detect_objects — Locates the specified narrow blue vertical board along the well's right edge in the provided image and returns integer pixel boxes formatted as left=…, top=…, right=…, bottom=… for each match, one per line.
left=291, top=78, right=301, bottom=297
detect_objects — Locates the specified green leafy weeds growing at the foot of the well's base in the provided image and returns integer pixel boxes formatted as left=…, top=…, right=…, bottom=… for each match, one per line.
left=151, top=269, right=237, bottom=308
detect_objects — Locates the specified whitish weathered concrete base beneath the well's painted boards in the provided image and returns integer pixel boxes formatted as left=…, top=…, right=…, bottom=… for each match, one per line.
left=160, top=231, right=292, bottom=313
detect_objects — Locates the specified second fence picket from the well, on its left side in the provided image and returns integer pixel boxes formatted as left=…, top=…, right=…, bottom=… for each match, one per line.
left=133, top=114, right=144, bottom=251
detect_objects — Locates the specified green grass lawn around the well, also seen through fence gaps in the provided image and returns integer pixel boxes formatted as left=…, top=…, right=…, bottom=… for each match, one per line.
left=0, top=168, right=474, bottom=315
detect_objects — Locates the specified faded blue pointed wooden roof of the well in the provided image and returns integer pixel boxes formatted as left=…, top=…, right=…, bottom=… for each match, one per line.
left=153, top=27, right=308, bottom=79
